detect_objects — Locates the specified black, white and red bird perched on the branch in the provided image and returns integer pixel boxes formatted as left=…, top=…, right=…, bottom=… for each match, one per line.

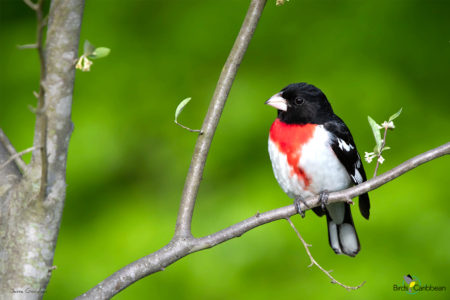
left=265, top=82, right=370, bottom=257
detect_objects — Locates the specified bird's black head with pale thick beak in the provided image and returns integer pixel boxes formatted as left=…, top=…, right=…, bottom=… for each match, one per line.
left=265, top=82, right=333, bottom=124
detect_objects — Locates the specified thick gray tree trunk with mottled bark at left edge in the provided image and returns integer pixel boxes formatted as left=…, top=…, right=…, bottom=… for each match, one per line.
left=0, top=0, right=84, bottom=299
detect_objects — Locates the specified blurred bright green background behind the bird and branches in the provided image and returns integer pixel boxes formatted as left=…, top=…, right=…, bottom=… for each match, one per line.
left=0, top=0, right=450, bottom=299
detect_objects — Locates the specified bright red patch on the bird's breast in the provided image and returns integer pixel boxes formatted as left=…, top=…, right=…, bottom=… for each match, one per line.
left=270, top=118, right=317, bottom=187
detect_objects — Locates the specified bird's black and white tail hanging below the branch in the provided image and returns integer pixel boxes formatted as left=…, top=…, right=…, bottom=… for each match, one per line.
left=326, top=202, right=360, bottom=256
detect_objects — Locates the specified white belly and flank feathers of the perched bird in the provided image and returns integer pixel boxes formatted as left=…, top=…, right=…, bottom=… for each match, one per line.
left=269, top=125, right=351, bottom=198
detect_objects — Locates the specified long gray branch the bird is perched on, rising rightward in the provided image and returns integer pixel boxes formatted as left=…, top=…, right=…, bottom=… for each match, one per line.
left=77, top=142, right=450, bottom=299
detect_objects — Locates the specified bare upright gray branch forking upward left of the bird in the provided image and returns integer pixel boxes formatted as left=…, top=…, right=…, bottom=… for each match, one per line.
left=175, top=0, right=266, bottom=238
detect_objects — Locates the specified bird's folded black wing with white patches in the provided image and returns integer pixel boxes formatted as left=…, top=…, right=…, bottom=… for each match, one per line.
left=324, top=115, right=370, bottom=219
